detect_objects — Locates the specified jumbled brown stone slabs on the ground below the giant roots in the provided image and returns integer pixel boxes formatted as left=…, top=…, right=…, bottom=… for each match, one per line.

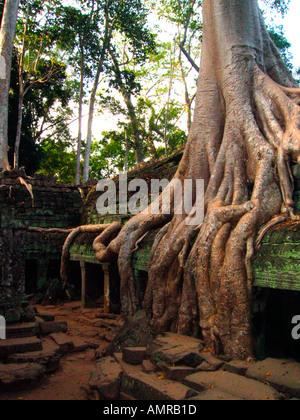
left=89, top=333, right=300, bottom=401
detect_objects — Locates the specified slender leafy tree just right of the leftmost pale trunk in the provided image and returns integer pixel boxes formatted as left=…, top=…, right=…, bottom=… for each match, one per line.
left=14, top=0, right=70, bottom=169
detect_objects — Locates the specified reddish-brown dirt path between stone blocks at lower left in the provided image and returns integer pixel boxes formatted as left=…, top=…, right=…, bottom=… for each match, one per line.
left=0, top=302, right=123, bottom=401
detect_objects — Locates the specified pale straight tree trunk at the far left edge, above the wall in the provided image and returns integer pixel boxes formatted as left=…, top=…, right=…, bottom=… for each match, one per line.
left=0, top=0, right=19, bottom=170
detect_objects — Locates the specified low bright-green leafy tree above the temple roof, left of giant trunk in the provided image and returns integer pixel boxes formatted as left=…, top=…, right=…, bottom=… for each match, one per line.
left=90, top=97, right=187, bottom=179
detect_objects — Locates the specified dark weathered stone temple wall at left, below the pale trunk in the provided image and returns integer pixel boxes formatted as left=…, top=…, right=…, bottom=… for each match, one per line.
left=0, top=171, right=84, bottom=322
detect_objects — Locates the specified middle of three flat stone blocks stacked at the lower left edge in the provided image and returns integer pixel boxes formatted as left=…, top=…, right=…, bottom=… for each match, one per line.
left=0, top=337, right=43, bottom=358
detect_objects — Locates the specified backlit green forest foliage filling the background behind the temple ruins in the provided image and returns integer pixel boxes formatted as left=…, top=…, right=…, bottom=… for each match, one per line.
left=0, top=0, right=298, bottom=182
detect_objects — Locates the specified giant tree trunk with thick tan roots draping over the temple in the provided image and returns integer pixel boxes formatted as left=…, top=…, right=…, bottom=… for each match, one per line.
left=91, top=0, right=300, bottom=359
